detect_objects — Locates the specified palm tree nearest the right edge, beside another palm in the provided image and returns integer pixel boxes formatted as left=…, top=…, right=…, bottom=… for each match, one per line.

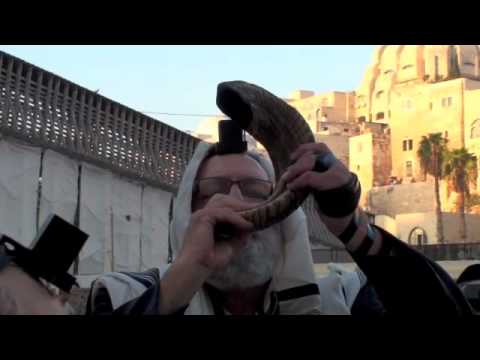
left=443, top=148, right=477, bottom=241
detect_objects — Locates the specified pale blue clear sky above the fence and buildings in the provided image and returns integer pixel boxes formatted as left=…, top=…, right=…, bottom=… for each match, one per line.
left=0, top=45, right=375, bottom=131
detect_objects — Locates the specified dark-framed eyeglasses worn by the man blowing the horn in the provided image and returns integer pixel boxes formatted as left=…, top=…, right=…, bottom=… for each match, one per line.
left=194, top=177, right=273, bottom=204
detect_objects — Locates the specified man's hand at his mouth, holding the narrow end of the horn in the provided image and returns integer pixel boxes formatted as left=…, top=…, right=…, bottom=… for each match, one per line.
left=180, top=194, right=253, bottom=271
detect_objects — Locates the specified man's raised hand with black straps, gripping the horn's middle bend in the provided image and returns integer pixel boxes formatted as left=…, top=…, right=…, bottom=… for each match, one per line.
left=283, top=143, right=353, bottom=235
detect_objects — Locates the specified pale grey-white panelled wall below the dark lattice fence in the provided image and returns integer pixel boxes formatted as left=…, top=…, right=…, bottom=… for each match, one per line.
left=0, top=138, right=172, bottom=287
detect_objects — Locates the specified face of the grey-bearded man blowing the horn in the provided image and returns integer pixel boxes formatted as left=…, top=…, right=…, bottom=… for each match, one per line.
left=192, top=154, right=281, bottom=290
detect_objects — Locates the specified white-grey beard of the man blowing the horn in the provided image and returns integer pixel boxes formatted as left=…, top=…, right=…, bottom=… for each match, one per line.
left=207, top=225, right=282, bottom=291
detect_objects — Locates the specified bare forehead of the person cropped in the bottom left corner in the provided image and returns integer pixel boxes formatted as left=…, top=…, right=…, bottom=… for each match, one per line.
left=0, top=265, right=67, bottom=315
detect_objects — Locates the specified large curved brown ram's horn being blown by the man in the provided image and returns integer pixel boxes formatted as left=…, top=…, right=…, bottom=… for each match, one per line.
left=217, top=81, right=315, bottom=230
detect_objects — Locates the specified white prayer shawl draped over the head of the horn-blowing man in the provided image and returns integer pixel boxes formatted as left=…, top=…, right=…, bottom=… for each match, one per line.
left=170, top=142, right=320, bottom=314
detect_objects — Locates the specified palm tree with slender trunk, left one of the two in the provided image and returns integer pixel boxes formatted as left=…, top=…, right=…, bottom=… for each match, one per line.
left=417, top=133, right=447, bottom=244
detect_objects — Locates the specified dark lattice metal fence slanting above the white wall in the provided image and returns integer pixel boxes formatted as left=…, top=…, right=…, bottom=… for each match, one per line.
left=0, top=52, right=199, bottom=192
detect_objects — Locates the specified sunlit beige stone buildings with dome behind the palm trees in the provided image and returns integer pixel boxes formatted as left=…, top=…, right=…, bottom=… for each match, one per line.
left=192, top=45, right=480, bottom=242
